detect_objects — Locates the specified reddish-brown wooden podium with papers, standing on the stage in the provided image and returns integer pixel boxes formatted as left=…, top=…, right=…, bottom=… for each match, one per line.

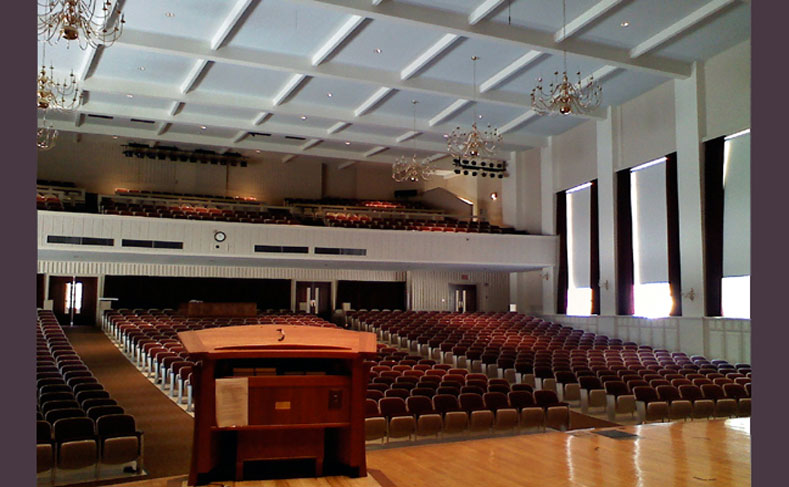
left=178, top=325, right=376, bottom=485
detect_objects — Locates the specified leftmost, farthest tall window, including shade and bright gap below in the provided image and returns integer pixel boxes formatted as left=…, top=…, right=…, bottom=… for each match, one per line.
left=565, top=183, right=592, bottom=316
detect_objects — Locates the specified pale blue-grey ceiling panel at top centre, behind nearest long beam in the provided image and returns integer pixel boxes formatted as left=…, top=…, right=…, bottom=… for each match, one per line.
left=331, top=20, right=444, bottom=72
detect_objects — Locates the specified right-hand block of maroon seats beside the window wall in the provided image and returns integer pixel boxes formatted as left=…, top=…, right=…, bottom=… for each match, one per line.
left=348, top=310, right=751, bottom=428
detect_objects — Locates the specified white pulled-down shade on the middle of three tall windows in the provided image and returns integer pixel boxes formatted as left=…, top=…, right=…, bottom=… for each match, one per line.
left=630, top=159, right=668, bottom=286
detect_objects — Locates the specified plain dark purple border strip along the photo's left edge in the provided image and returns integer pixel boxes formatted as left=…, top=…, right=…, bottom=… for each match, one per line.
left=8, top=2, right=37, bottom=485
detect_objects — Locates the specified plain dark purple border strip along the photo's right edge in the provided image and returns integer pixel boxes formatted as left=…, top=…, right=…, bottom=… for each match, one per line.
left=750, top=2, right=789, bottom=487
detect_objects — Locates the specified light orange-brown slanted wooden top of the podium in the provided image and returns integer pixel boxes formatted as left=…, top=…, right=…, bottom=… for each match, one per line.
left=178, top=325, right=376, bottom=359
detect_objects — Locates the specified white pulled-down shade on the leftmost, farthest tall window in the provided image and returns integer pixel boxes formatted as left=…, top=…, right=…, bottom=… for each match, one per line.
left=567, top=187, right=592, bottom=288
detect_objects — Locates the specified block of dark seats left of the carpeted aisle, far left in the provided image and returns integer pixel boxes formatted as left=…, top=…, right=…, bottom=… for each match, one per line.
left=36, top=310, right=143, bottom=484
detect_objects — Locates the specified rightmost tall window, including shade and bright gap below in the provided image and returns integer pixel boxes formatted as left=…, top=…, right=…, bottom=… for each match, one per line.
left=721, top=130, right=751, bottom=318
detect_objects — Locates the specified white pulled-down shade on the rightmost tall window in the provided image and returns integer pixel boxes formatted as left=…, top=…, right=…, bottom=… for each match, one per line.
left=723, top=134, right=751, bottom=277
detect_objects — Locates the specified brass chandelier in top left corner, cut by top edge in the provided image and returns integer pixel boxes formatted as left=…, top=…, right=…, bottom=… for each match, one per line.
left=38, top=0, right=126, bottom=49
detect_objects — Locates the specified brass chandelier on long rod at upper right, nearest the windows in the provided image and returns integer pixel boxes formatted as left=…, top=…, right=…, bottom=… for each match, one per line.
left=531, top=0, right=603, bottom=115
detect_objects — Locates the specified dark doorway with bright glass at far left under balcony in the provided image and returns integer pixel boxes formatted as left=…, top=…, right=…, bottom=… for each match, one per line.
left=49, top=276, right=98, bottom=326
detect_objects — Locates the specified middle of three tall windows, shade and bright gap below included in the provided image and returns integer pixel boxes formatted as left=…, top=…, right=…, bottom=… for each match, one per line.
left=630, top=157, right=674, bottom=318
